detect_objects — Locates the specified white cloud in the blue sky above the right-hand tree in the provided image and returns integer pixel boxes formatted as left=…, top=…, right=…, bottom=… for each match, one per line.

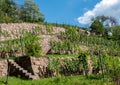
left=78, top=0, right=120, bottom=24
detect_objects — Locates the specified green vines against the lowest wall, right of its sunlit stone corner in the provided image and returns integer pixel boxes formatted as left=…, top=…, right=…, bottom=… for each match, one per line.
left=48, top=57, right=83, bottom=76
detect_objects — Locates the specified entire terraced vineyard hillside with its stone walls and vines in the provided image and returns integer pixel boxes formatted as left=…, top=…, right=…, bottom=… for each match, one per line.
left=0, top=23, right=120, bottom=82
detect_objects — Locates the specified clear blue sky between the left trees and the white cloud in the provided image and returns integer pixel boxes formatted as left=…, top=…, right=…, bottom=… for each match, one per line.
left=35, top=0, right=98, bottom=25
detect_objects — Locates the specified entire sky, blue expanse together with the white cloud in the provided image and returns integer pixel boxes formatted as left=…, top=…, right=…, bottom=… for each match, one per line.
left=16, top=0, right=120, bottom=26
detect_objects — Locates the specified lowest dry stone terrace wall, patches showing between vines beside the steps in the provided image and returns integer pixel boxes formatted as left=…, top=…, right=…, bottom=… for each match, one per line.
left=0, top=57, right=93, bottom=78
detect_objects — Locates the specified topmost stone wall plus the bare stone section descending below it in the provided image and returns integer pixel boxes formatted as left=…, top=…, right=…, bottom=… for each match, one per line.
left=0, top=23, right=65, bottom=56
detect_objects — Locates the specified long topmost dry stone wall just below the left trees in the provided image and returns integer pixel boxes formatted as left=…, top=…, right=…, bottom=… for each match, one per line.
left=0, top=23, right=65, bottom=41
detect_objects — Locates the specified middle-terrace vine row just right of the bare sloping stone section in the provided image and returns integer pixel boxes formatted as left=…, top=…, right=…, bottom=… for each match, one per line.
left=50, top=40, right=79, bottom=54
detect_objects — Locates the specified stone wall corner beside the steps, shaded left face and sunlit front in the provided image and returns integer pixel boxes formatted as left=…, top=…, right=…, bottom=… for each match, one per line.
left=16, top=57, right=48, bottom=77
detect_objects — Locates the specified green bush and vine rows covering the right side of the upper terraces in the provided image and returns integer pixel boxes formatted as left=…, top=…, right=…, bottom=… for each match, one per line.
left=50, top=23, right=120, bottom=56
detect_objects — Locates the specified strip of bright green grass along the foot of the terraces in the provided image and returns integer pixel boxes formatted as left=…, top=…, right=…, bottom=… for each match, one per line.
left=0, top=76, right=113, bottom=85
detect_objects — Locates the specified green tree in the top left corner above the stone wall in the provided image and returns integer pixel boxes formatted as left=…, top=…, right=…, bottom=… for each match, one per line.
left=0, top=0, right=19, bottom=23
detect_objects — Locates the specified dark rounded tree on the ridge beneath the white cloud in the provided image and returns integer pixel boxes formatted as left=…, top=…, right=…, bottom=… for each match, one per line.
left=90, top=15, right=117, bottom=37
